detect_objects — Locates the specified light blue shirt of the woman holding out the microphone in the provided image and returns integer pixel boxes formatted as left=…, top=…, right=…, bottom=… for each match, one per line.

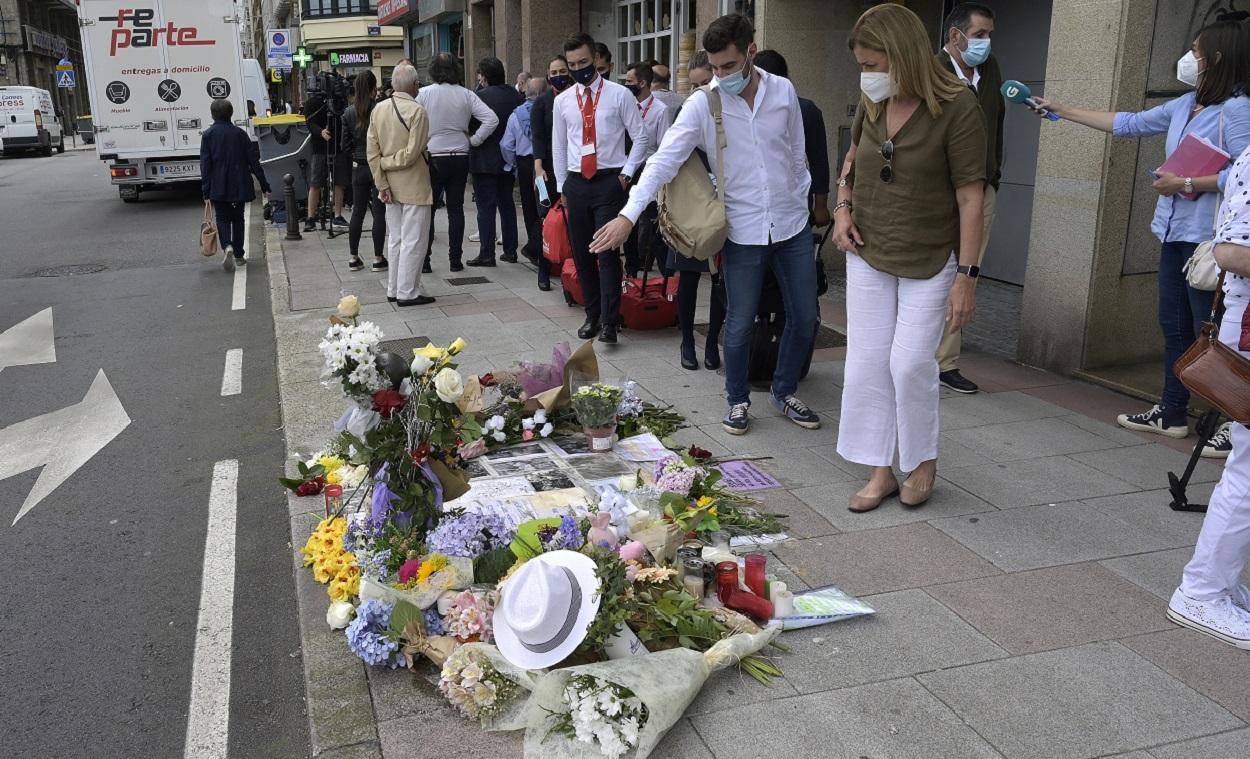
left=1113, top=93, right=1250, bottom=243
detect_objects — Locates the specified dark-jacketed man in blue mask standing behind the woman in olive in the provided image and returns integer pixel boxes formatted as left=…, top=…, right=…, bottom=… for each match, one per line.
left=938, top=3, right=1006, bottom=394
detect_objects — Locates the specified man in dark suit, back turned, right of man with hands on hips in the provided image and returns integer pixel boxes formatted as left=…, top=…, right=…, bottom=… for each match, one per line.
left=465, top=58, right=524, bottom=266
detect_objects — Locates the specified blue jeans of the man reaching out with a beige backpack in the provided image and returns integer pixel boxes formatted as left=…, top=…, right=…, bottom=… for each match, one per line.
left=721, top=226, right=818, bottom=404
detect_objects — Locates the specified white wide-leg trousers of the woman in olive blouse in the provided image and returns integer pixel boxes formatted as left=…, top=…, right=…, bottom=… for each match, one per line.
left=838, top=253, right=955, bottom=471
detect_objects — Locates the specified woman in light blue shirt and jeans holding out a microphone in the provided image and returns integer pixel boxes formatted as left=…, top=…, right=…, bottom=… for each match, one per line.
left=1036, top=20, right=1250, bottom=458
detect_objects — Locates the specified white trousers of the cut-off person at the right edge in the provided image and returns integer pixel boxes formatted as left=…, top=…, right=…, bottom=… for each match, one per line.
left=1180, top=296, right=1250, bottom=601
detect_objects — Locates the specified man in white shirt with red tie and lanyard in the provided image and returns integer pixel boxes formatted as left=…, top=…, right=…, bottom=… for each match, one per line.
left=551, top=34, right=654, bottom=344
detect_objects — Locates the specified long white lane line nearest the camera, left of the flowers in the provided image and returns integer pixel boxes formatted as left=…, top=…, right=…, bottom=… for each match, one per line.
left=183, top=459, right=239, bottom=759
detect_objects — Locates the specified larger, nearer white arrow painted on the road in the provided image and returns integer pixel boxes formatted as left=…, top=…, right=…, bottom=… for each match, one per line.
left=0, top=370, right=130, bottom=524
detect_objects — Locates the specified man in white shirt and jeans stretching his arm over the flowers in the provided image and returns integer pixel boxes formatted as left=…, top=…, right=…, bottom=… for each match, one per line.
left=590, top=14, right=820, bottom=435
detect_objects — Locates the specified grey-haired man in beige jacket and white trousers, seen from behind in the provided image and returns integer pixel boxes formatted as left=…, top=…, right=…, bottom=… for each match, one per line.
left=368, top=65, right=434, bottom=306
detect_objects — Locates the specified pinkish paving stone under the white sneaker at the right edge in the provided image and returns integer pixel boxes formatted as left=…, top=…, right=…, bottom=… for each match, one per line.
left=1120, top=626, right=1250, bottom=725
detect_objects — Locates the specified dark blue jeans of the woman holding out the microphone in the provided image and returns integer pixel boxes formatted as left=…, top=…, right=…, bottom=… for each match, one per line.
left=1159, top=243, right=1215, bottom=424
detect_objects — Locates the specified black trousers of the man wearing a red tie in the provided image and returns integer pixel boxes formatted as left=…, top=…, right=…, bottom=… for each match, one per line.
left=564, top=169, right=628, bottom=325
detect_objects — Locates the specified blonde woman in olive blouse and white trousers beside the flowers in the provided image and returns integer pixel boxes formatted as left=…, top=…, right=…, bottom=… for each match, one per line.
left=834, top=4, right=985, bottom=511
